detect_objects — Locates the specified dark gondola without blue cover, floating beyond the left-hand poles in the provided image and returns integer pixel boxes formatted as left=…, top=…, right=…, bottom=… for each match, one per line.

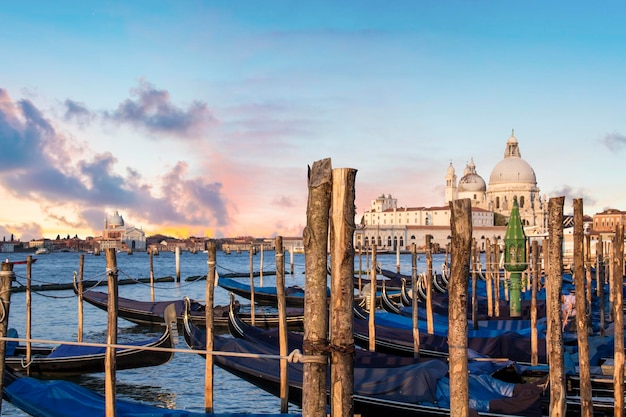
left=78, top=290, right=304, bottom=329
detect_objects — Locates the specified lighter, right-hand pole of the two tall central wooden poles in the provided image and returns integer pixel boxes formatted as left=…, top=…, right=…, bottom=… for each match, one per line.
left=330, top=168, right=356, bottom=417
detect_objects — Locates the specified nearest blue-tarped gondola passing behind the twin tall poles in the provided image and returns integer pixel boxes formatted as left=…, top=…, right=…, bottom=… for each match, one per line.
left=184, top=298, right=544, bottom=417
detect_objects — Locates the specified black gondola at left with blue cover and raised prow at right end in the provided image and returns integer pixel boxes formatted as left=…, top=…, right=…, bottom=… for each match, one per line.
left=5, top=307, right=177, bottom=377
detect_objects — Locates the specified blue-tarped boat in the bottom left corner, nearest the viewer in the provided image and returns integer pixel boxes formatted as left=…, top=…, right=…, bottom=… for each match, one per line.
left=3, top=368, right=300, bottom=417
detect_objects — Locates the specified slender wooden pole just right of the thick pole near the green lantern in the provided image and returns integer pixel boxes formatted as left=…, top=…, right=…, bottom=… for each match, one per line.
left=573, top=198, right=588, bottom=417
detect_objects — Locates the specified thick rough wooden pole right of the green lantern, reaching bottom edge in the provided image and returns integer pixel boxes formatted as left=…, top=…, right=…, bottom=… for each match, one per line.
left=546, top=197, right=567, bottom=417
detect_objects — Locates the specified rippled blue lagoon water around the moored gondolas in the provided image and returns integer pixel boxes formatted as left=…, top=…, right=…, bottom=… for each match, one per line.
left=0, top=252, right=443, bottom=416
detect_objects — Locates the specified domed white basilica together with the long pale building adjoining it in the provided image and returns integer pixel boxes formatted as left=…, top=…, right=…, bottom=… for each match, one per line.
left=354, top=133, right=547, bottom=251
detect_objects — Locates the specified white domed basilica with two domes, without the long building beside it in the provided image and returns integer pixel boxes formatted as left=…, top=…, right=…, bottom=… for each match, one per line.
left=445, top=131, right=547, bottom=233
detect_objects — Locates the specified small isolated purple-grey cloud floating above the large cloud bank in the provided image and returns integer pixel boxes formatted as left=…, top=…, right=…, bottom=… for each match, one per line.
left=103, top=80, right=217, bottom=138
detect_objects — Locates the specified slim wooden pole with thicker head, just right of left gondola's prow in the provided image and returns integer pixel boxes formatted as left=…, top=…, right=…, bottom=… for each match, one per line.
left=204, top=240, right=217, bottom=413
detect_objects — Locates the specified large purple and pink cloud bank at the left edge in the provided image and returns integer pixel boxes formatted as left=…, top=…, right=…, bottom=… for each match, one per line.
left=0, top=90, right=230, bottom=237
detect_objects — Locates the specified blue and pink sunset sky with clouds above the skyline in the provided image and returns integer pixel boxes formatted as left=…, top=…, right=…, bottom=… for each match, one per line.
left=0, top=0, right=626, bottom=241
